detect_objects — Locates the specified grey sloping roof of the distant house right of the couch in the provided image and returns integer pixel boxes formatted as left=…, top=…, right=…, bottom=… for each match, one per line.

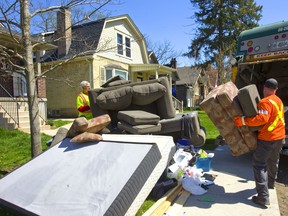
left=176, top=67, right=201, bottom=86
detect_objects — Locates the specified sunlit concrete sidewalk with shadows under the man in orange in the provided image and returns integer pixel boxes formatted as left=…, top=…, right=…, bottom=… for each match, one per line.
left=180, top=145, right=280, bottom=216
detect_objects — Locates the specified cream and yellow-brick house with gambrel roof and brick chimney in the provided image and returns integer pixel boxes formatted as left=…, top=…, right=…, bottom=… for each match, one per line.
left=41, top=10, right=176, bottom=117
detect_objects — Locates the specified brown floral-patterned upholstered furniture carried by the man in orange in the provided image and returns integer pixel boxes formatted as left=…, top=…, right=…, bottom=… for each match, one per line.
left=200, top=82, right=257, bottom=156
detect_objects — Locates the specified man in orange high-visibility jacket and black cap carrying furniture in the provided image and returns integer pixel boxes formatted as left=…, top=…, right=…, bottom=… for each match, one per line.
left=234, top=78, right=285, bottom=206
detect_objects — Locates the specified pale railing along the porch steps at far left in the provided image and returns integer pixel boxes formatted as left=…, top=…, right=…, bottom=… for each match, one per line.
left=0, top=84, right=19, bottom=127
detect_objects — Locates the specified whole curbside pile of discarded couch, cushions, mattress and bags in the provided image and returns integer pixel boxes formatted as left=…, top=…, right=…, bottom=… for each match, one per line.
left=0, top=77, right=211, bottom=215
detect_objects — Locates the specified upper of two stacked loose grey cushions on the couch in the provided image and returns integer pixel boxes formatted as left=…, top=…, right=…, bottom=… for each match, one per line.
left=117, top=110, right=160, bottom=125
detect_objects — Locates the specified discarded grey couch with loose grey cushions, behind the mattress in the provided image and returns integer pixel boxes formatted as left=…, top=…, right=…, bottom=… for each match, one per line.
left=88, top=77, right=206, bottom=146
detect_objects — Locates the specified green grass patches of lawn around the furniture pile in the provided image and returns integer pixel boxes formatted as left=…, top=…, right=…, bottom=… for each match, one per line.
left=0, top=110, right=219, bottom=216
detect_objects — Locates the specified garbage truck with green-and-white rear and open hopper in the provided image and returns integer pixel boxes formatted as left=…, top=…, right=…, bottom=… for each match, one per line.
left=231, top=21, right=288, bottom=154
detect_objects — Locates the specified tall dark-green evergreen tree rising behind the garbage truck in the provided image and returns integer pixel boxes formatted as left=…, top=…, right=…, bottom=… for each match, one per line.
left=184, top=0, right=262, bottom=85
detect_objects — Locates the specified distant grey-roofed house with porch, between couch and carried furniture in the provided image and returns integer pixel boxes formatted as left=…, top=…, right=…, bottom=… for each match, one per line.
left=173, top=67, right=211, bottom=108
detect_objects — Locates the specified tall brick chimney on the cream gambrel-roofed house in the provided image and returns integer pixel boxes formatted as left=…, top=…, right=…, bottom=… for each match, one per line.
left=56, top=8, right=72, bottom=58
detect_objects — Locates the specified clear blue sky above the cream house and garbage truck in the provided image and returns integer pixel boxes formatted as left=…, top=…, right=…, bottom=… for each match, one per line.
left=109, top=0, right=288, bottom=67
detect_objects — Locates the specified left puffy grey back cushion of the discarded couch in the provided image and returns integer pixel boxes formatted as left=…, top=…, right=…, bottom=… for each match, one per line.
left=96, top=86, right=132, bottom=110
